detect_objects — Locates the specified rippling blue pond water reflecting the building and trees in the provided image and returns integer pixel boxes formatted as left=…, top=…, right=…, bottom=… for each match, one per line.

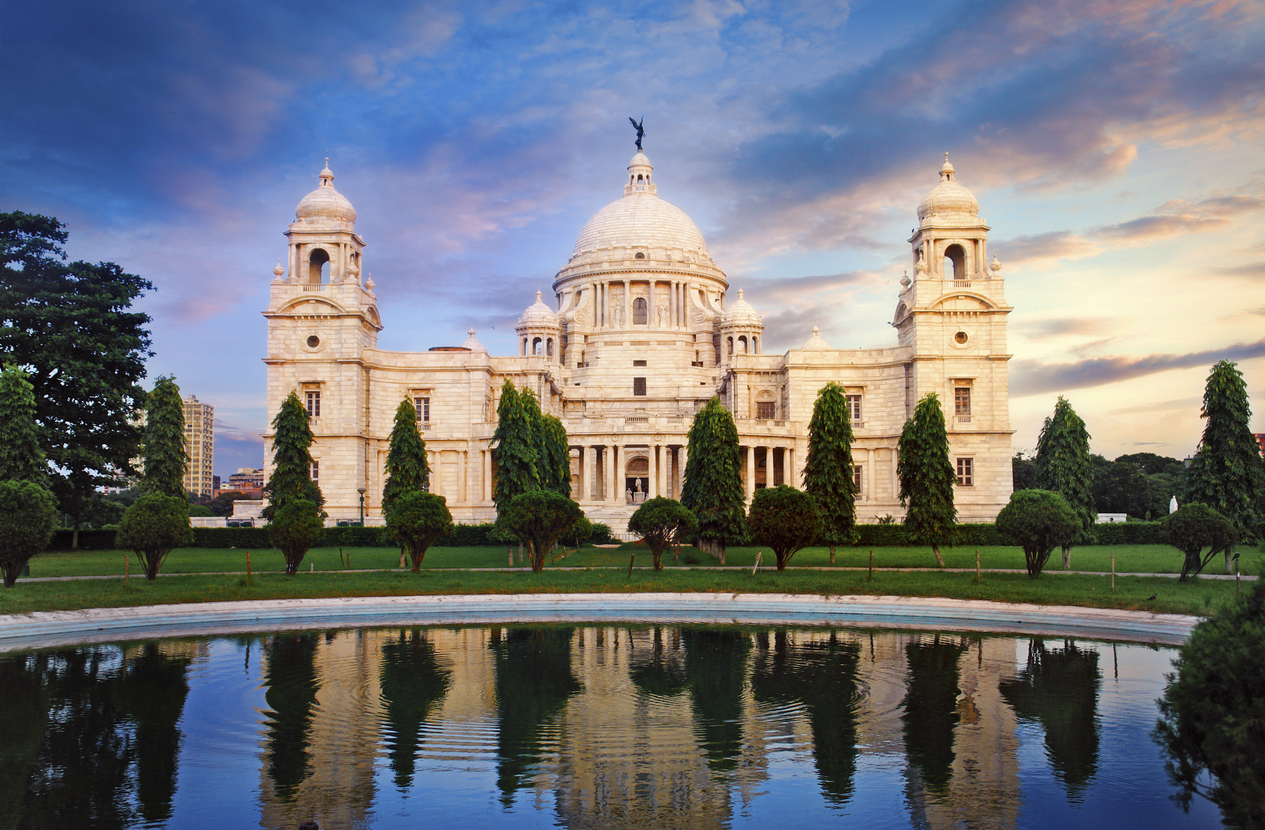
left=0, top=625, right=1219, bottom=830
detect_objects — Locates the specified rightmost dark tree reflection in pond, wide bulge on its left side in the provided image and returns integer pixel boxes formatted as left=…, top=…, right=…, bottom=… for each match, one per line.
left=1001, top=640, right=1102, bottom=801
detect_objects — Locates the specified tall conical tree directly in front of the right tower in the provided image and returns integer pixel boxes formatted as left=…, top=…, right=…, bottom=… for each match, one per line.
left=896, top=392, right=958, bottom=568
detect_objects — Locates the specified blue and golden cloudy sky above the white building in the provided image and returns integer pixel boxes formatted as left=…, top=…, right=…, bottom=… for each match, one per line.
left=0, top=0, right=1265, bottom=478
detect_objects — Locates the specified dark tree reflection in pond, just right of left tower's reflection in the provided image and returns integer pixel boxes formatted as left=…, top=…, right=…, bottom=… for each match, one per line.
left=382, top=630, right=452, bottom=791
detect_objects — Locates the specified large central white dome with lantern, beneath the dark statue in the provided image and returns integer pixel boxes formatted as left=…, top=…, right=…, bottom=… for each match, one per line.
left=572, top=153, right=707, bottom=258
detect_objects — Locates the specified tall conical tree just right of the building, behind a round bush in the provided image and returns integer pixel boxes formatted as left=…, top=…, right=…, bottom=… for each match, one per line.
left=1032, top=395, right=1098, bottom=568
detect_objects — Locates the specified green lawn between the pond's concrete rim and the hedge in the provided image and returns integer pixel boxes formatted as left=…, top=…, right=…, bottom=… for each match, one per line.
left=0, top=545, right=1260, bottom=615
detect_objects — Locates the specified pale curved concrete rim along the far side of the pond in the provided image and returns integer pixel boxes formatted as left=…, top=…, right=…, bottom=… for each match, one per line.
left=0, top=593, right=1199, bottom=653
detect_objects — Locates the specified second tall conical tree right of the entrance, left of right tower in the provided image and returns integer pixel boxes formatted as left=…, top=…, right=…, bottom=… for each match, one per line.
left=803, top=381, right=856, bottom=564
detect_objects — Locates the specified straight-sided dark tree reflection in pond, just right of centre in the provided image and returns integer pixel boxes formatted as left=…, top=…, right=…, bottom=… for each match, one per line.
left=681, top=629, right=750, bottom=773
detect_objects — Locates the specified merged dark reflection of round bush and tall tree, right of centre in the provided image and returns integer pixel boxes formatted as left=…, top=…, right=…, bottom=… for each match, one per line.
left=751, top=631, right=860, bottom=805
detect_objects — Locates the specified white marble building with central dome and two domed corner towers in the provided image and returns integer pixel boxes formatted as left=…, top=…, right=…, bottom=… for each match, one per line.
left=264, top=152, right=1012, bottom=530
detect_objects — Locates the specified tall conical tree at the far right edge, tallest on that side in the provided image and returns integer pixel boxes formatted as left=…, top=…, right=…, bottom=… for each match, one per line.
left=1185, top=361, right=1265, bottom=571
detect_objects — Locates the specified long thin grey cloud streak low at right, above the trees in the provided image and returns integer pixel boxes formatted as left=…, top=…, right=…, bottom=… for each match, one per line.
left=1011, top=339, right=1265, bottom=397
